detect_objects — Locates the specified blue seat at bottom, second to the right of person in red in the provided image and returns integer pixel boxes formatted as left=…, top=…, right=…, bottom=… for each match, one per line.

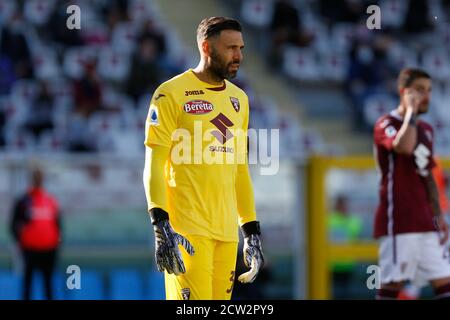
left=110, top=269, right=144, bottom=300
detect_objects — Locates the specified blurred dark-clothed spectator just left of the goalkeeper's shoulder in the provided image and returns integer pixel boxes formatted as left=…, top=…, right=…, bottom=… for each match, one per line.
left=127, top=36, right=167, bottom=101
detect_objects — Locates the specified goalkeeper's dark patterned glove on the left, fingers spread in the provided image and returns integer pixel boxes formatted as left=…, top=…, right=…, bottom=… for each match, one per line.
left=150, top=208, right=194, bottom=275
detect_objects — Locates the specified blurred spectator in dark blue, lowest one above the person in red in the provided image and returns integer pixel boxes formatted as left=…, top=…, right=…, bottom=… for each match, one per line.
left=25, top=81, right=54, bottom=139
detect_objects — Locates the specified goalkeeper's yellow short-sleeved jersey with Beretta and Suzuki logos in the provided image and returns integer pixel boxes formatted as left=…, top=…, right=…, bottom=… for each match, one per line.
left=145, top=69, right=253, bottom=241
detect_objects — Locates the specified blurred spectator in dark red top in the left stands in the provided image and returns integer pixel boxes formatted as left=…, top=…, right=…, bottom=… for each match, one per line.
left=74, top=61, right=102, bottom=119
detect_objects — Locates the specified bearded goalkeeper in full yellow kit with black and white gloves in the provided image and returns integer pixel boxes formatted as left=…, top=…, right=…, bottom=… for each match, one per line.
left=144, top=17, right=264, bottom=300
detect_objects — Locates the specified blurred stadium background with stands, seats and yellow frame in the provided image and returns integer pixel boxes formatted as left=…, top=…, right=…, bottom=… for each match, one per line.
left=0, top=0, right=450, bottom=299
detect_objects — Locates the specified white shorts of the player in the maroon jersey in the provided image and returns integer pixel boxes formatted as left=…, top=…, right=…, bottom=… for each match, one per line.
left=379, top=232, right=450, bottom=287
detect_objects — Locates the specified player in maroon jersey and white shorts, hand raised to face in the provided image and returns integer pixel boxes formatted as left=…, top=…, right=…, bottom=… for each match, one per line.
left=374, top=68, right=450, bottom=299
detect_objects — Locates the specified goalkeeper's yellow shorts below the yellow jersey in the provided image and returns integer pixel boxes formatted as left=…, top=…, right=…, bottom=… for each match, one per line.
left=164, top=235, right=238, bottom=300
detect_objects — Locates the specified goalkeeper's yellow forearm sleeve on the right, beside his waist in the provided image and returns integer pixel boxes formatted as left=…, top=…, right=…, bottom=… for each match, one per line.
left=236, top=163, right=256, bottom=226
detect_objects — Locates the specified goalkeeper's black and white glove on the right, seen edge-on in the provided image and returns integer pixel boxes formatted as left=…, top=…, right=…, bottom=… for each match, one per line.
left=238, top=221, right=264, bottom=283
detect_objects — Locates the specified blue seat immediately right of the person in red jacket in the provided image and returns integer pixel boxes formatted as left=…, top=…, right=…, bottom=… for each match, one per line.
left=66, top=270, right=105, bottom=300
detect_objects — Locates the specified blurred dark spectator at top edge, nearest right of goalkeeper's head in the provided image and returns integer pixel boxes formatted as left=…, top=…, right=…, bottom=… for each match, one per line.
left=270, top=0, right=313, bottom=66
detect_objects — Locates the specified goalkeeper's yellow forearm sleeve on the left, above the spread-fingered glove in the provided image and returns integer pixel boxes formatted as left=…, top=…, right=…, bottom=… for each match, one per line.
left=143, top=145, right=170, bottom=212
